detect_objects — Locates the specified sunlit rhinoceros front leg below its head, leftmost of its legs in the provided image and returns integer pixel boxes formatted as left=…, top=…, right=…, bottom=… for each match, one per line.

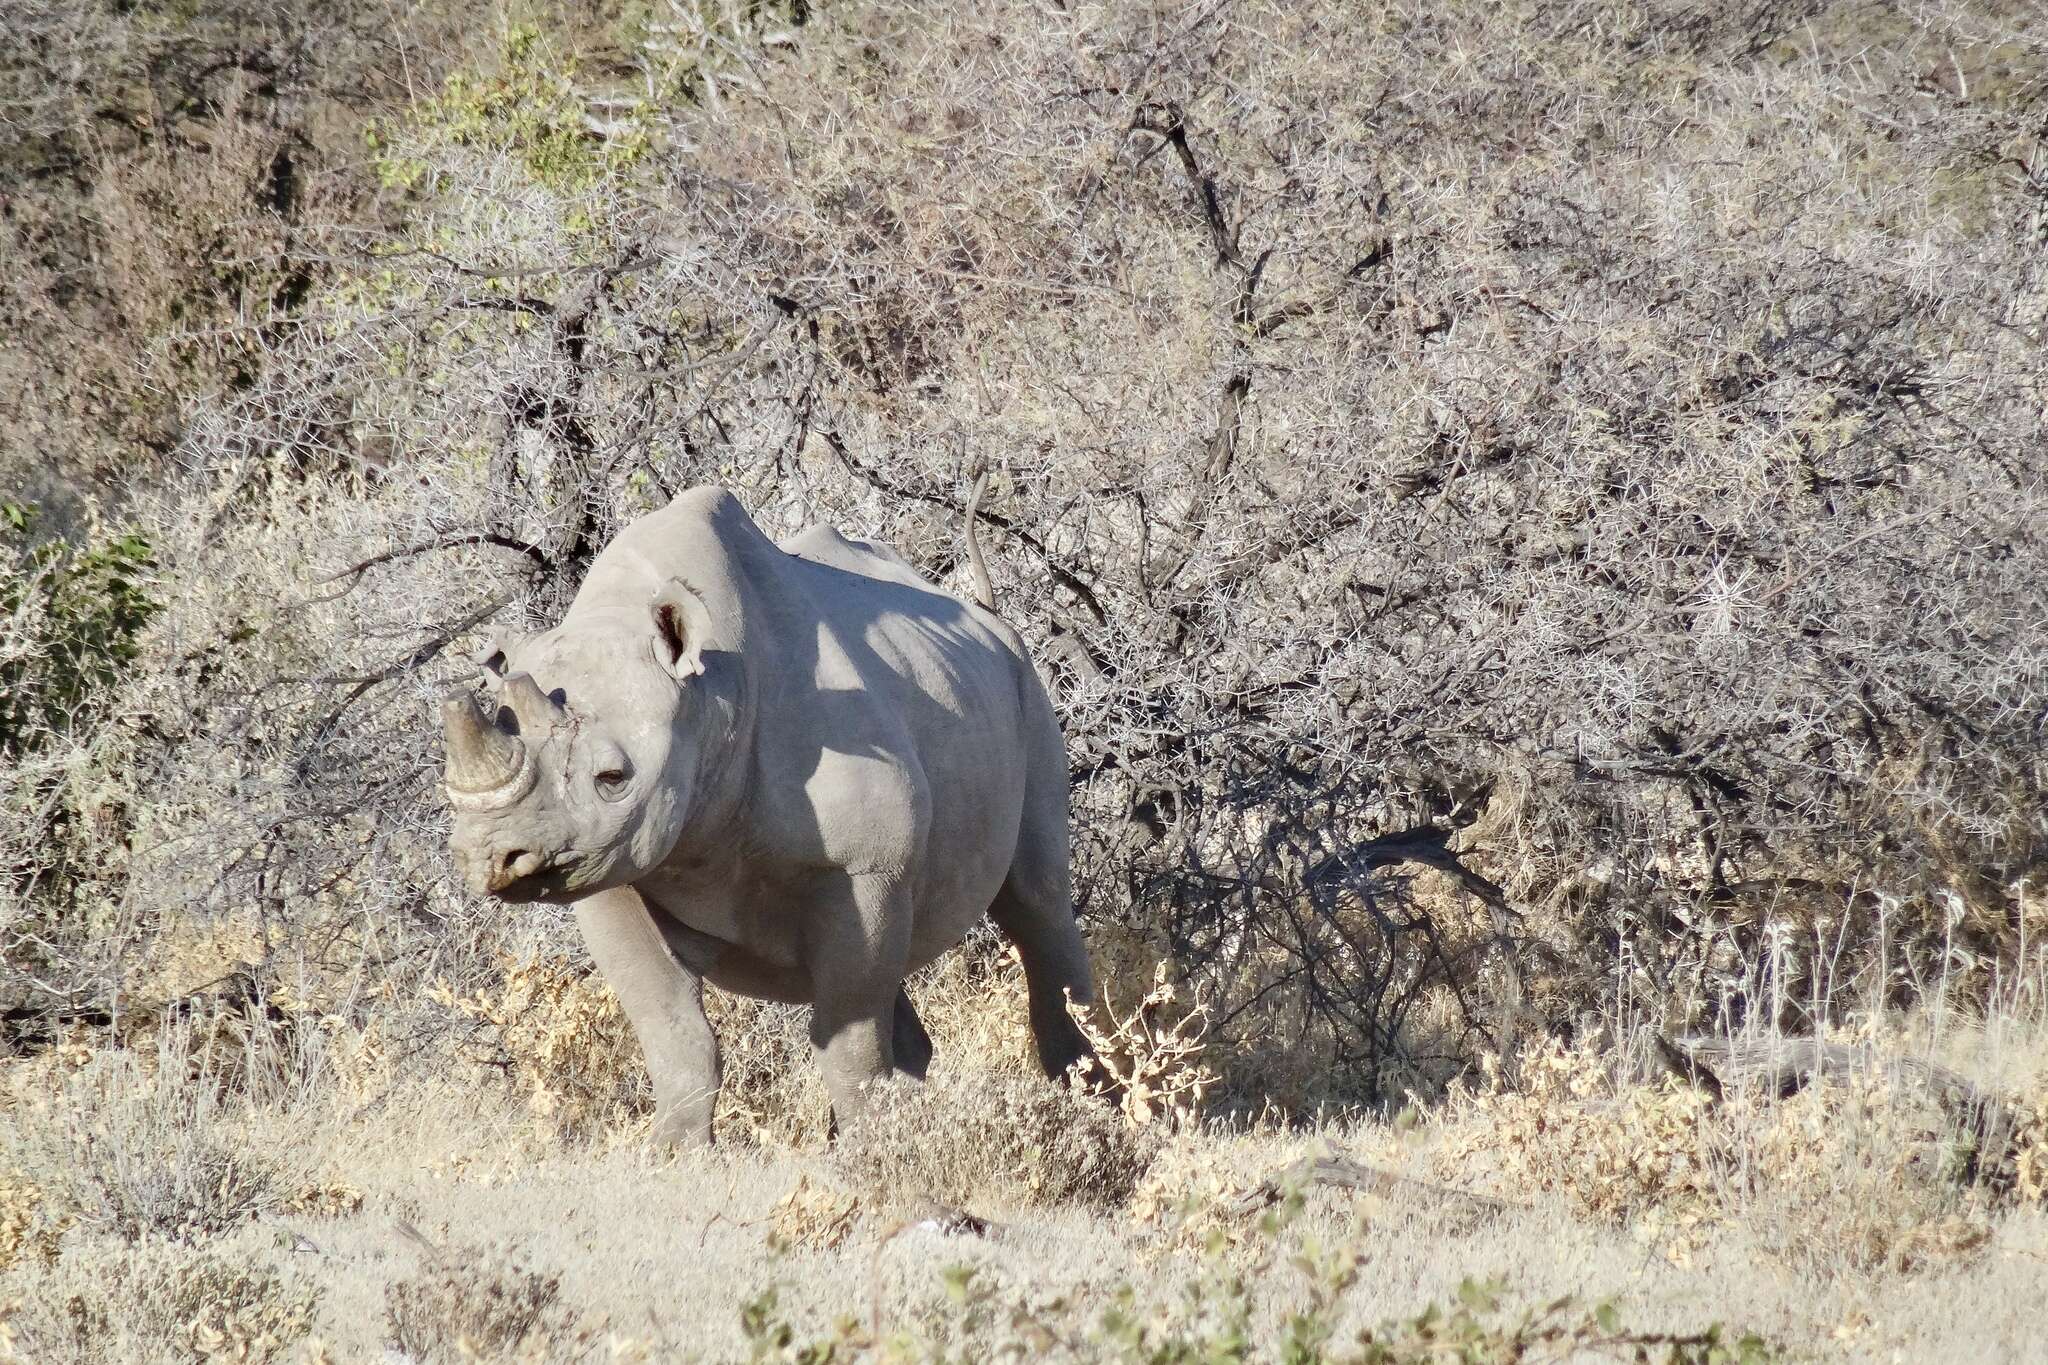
left=575, top=886, right=719, bottom=1146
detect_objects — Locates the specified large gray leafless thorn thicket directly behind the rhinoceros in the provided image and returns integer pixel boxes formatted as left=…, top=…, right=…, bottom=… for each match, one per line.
left=4, top=0, right=2048, bottom=1099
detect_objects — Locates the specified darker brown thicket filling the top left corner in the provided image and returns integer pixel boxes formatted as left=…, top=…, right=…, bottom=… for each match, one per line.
left=0, top=0, right=497, bottom=526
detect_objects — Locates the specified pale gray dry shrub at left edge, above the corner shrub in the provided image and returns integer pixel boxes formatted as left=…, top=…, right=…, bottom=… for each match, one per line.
left=0, top=1050, right=289, bottom=1242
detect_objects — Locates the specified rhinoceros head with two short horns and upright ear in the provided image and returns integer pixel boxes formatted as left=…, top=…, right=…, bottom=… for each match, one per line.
left=440, top=583, right=709, bottom=900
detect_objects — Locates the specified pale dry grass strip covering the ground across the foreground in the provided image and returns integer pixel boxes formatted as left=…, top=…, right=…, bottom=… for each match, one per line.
left=4, top=998, right=2048, bottom=1361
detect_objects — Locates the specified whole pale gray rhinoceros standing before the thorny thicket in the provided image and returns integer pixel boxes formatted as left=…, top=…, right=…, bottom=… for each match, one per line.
left=442, top=489, right=1094, bottom=1144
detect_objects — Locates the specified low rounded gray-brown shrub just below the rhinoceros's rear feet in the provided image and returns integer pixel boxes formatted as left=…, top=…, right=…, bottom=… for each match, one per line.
left=834, top=1070, right=1153, bottom=1212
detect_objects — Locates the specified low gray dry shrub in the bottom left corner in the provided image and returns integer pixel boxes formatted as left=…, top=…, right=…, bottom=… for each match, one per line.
left=8, top=1240, right=319, bottom=1365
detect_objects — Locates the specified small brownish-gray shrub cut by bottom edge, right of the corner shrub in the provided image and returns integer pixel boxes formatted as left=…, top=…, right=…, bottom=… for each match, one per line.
left=385, top=1246, right=592, bottom=1365
